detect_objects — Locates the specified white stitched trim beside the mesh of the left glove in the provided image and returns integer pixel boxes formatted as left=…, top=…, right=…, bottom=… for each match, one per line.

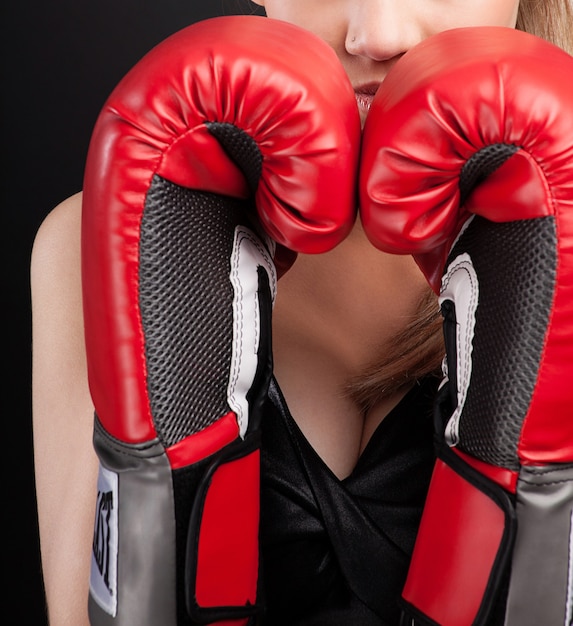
left=227, top=226, right=277, bottom=437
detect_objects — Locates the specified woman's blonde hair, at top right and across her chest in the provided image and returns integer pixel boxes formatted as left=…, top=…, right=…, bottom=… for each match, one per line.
left=346, top=0, right=573, bottom=412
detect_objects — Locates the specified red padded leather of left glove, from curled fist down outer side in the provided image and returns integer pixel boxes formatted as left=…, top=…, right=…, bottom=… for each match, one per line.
left=82, top=16, right=360, bottom=443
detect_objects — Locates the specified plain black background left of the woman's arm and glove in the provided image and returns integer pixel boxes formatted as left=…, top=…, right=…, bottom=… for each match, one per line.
left=0, top=0, right=264, bottom=626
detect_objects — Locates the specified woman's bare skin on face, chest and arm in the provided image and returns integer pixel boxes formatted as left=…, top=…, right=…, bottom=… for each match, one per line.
left=31, top=0, right=518, bottom=626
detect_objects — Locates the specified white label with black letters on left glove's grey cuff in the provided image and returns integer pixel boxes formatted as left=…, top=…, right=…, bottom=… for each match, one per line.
left=90, top=465, right=118, bottom=617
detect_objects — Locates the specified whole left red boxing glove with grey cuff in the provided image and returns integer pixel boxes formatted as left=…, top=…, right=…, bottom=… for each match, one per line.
left=82, top=16, right=360, bottom=626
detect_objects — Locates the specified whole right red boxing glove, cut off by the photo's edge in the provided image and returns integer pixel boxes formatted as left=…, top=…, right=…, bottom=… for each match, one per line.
left=360, top=27, right=573, bottom=626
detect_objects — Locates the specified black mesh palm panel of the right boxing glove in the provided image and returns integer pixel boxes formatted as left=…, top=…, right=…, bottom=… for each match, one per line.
left=448, top=217, right=557, bottom=470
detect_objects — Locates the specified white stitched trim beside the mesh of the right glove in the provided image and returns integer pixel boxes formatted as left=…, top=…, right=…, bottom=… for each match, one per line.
left=439, top=253, right=479, bottom=446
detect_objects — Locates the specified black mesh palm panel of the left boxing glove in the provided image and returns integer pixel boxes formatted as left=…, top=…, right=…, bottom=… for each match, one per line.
left=139, top=176, right=254, bottom=447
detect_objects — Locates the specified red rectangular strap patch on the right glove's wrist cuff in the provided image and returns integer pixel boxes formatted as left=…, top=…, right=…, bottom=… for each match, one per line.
left=402, top=460, right=505, bottom=626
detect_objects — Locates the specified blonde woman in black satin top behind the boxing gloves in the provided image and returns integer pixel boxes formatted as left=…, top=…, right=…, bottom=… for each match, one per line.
left=32, top=0, right=573, bottom=625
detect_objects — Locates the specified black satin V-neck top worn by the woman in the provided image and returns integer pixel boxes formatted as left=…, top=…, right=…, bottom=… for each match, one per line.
left=261, top=378, right=437, bottom=626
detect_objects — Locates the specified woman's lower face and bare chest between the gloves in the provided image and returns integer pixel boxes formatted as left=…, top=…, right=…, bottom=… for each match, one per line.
left=252, top=0, right=519, bottom=478
